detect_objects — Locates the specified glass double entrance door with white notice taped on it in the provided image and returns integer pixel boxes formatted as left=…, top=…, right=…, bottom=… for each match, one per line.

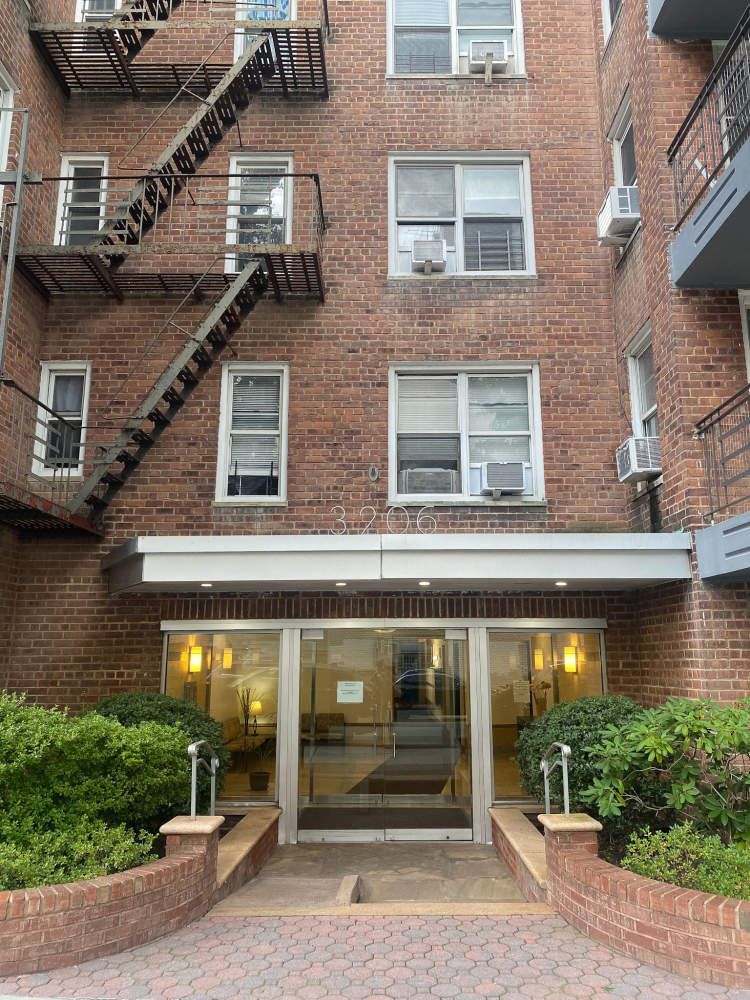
left=298, top=628, right=472, bottom=841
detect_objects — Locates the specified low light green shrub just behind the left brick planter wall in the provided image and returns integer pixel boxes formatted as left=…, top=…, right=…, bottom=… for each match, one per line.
left=0, top=820, right=156, bottom=891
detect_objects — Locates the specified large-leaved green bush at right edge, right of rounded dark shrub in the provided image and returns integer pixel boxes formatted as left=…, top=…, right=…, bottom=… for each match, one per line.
left=582, top=698, right=750, bottom=847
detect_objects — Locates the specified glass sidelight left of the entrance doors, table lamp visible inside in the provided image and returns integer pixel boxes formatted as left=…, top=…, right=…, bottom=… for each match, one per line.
left=165, top=633, right=280, bottom=802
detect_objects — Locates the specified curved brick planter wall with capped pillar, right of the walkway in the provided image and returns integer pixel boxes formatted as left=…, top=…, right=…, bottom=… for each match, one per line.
left=540, top=815, right=750, bottom=989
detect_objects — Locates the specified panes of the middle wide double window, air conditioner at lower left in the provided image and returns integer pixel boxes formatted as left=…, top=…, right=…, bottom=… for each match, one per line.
left=393, top=163, right=527, bottom=274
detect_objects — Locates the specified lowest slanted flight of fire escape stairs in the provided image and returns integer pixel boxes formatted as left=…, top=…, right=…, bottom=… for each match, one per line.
left=67, top=261, right=267, bottom=522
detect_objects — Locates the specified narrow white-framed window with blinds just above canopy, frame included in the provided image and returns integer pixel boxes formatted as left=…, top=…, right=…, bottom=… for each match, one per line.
left=216, top=362, right=289, bottom=504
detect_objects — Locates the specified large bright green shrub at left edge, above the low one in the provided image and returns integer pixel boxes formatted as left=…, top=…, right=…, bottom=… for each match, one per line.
left=0, top=693, right=190, bottom=850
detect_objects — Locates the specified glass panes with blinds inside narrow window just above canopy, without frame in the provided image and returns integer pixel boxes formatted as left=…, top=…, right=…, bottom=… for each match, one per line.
left=225, top=372, right=283, bottom=497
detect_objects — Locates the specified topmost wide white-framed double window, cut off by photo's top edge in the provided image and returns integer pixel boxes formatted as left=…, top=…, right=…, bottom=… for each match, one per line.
left=386, top=0, right=524, bottom=76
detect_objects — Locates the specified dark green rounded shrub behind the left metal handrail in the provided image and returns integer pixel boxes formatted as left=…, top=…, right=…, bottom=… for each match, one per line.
left=94, top=691, right=232, bottom=813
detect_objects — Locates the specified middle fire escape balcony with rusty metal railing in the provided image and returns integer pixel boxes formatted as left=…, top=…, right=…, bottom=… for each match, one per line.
left=17, top=173, right=325, bottom=300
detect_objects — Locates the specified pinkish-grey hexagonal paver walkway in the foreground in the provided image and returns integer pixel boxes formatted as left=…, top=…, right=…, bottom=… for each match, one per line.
left=0, top=915, right=750, bottom=1000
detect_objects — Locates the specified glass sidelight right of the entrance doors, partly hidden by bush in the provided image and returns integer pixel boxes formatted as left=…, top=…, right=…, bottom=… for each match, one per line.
left=489, top=632, right=603, bottom=800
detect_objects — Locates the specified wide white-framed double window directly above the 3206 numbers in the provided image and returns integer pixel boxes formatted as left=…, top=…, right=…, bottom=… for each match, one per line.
left=388, top=362, right=544, bottom=503
